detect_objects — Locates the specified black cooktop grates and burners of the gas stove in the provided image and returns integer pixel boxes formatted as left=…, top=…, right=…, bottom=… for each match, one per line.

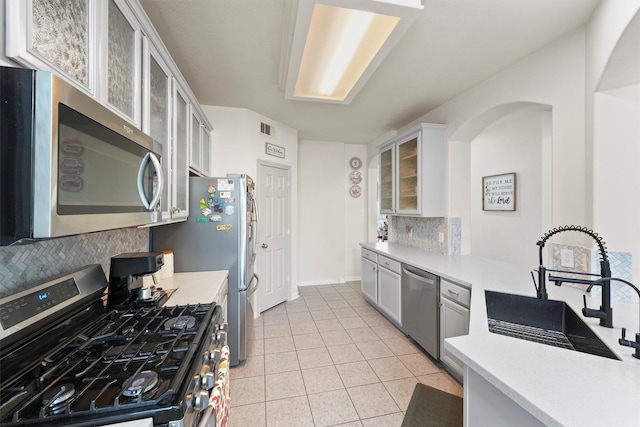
left=0, top=304, right=215, bottom=425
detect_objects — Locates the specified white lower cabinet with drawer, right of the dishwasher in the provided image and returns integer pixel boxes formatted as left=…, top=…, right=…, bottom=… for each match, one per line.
left=440, top=278, right=471, bottom=380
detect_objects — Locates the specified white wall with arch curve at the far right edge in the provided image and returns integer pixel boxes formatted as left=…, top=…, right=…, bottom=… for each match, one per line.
left=586, top=0, right=640, bottom=283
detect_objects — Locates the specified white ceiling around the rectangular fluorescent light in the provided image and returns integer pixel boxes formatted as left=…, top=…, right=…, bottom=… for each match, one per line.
left=140, top=0, right=598, bottom=143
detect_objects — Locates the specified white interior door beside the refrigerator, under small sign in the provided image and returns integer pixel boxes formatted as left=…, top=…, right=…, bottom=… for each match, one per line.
left=257, top=164, right=291, bottom=313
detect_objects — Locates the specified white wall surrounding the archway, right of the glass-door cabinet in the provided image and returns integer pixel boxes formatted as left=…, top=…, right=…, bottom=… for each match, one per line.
left=398, top=28, right=585, bottom=260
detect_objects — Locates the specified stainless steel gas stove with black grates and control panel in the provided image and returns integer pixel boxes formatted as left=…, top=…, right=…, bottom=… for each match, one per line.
left=0, top=266, right=226, bottom=427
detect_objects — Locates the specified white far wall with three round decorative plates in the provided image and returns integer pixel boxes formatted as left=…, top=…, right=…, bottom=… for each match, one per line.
left=298, top=140, right=367, bottom=285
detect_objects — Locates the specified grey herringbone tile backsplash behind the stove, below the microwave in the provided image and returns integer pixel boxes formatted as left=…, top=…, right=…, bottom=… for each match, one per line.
left=0, top=228, right=149, bottom=298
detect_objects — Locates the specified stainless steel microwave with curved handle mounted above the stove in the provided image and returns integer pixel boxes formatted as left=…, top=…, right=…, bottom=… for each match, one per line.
left=0, top=67, right=163, bottom=245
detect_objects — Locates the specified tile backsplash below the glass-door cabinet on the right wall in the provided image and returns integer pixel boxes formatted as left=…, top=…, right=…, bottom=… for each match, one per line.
left=390, top=216, right=462, bottom=255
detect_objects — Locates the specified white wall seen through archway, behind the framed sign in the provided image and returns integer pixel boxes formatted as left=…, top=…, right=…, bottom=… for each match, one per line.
left=469, top=111, right=545, bottom=268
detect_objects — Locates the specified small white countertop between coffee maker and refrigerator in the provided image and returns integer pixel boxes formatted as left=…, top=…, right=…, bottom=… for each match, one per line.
left=151, top=270, right=229, bottom=305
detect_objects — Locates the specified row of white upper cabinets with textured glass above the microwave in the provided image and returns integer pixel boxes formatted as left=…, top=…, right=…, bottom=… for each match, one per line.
left=5, top=0, right=213, bottom=220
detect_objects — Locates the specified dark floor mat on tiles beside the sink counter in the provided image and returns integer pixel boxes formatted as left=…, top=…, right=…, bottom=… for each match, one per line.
left=402, top=383, right=462, bottom=427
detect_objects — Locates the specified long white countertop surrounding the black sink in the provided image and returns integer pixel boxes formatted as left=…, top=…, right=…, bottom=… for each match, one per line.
left=361, top=242, right=640, bottom=426
